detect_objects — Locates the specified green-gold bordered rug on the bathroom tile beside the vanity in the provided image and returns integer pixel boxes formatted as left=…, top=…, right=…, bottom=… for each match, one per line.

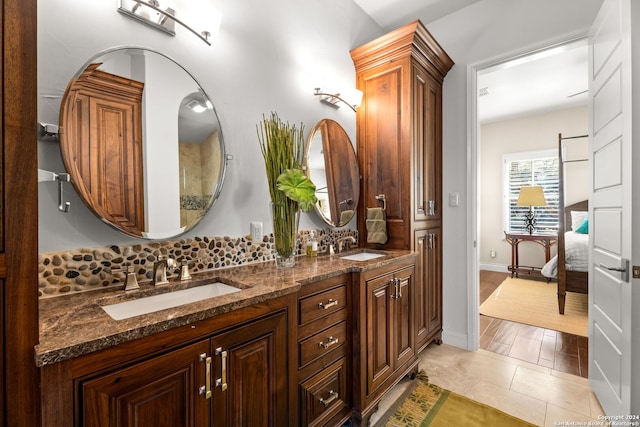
left=375, top=371, right=535, bottom=427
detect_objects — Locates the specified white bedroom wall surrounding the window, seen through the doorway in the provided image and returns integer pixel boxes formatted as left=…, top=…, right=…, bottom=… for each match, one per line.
left=478, top=107, right=589, bottom=271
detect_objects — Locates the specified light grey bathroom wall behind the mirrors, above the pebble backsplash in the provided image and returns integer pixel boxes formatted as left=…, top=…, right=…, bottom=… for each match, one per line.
left=38, top=0, right=383, bottom=252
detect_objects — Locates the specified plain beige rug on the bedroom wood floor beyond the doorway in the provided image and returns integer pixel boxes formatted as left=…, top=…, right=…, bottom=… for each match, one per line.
left=480, top=277, right=589, bottom=337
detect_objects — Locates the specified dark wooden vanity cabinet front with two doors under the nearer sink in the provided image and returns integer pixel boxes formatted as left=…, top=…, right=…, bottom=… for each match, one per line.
left=43, top=297, right=295, bottom=427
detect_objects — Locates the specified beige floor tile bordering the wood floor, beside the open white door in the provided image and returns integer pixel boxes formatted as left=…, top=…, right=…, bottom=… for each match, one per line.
left=511, top=367, right=591, bottom=417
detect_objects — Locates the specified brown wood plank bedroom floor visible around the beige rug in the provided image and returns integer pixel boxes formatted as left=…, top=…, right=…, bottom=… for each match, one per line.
left=480, top=270, right=589, bottom=378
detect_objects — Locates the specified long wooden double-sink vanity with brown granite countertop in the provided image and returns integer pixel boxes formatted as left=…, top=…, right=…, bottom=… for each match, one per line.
left=36, top=249, right=417, bottom=426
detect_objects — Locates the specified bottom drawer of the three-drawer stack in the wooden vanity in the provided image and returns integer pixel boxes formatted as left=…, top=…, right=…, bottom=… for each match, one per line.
left=300, top=357, right=351, bottom=426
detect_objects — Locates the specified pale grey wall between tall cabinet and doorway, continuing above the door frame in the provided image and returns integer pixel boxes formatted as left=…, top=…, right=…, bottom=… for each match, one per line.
left=426, top=0, right=602, bottom=348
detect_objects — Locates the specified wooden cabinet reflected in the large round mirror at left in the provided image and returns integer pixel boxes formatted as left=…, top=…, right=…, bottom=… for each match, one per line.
left=60, top=64, right=145, bottom=236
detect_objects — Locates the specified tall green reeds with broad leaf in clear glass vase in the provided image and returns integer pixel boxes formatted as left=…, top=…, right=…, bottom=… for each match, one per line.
left=258, top=113, right=317, bottom=267
